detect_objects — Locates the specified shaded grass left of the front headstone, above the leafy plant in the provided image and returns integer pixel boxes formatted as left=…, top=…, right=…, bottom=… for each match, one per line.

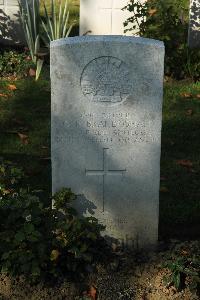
left=0, top=79, right=51, bottom=203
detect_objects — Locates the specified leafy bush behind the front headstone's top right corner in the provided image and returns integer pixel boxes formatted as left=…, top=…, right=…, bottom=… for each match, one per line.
left=124, top=0, right=200, bottom=79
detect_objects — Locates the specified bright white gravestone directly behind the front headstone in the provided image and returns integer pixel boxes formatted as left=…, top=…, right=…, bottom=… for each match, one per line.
left=80, top=0, right=145, bottom=35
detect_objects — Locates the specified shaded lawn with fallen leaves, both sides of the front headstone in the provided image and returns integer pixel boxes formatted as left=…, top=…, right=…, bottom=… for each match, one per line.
left=0, top=78, right=200, bottom=238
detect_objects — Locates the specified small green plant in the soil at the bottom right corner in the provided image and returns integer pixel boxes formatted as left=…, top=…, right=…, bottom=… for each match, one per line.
left=163, top=247, right=200, bottom=292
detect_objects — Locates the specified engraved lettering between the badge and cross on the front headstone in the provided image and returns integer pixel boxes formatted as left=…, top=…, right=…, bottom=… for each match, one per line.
left=57, top=111, right=159, bottom=148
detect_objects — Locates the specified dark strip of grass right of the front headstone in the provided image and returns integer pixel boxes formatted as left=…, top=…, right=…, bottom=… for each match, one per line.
left=160, top=79, right=200, bottom=237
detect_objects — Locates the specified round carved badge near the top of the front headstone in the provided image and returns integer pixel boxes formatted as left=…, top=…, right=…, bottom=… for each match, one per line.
left=81, top=56, right=131, bottom=103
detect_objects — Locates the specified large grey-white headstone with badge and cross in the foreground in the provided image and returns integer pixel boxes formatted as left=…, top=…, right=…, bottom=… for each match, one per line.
left=51, top=36, right=164, bottom=247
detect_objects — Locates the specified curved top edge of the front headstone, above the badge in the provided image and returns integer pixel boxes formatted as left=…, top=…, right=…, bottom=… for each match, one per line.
left=50, top=35, right=164, bottom=48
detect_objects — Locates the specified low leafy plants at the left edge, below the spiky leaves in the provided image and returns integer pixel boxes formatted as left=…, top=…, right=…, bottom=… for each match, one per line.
left=0, top=50, right=32, bottom=77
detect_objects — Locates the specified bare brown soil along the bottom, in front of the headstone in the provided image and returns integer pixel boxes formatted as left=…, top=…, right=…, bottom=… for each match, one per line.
left=0, top=240, right=200, bottom=300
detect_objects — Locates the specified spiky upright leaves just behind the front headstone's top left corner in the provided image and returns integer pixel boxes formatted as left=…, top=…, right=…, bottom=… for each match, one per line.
left=42, top=0, right=73, bottom=47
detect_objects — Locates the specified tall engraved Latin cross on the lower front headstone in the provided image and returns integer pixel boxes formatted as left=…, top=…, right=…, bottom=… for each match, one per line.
left=85, top=148, right=126, bottom=212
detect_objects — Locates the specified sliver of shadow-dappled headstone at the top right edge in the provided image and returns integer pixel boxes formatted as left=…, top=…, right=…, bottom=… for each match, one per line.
left=188, top=0, right=200, bottom=48
